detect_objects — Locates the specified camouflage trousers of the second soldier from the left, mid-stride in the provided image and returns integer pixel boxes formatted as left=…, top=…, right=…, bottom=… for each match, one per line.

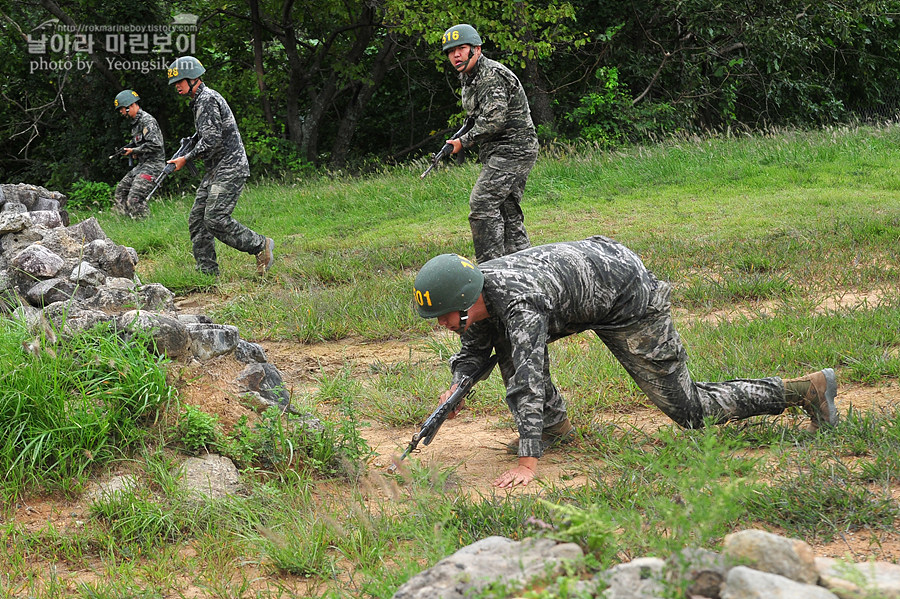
left=188, top=176, right=266, bottom=275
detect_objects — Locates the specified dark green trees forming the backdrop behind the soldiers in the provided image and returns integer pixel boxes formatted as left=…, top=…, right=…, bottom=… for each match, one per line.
left=0, top=0, right=900, bottom=191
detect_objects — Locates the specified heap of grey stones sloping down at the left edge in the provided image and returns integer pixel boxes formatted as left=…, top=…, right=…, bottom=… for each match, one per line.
left=0, top=184, right=292, bottom=410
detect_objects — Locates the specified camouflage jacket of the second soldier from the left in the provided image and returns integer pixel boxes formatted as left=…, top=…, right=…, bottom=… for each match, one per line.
left=187, top=83, right=250, bottom=178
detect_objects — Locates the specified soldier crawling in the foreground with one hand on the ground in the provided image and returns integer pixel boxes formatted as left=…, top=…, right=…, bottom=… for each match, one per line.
left=415, top=236, right=838, bottom=488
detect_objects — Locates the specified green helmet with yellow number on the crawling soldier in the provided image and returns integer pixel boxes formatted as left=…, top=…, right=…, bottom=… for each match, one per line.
left=413, top=254, right=484, bottom=318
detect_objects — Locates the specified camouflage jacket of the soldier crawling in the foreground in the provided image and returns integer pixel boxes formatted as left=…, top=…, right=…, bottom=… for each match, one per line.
left=450, top=236, right=657, bottom=457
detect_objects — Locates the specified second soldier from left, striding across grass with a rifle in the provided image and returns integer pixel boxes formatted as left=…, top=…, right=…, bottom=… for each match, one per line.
left=168, top=56, right=275, bottom=276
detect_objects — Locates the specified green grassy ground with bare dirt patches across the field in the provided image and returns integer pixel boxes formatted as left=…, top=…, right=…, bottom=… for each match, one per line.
left=0, top=127, right=900, bottom=598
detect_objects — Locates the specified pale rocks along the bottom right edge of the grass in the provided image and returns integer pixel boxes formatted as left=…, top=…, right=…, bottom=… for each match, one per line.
left=394, top=530, right=900, bottom=599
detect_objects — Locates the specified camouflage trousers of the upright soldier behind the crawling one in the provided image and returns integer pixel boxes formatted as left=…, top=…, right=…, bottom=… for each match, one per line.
left=469, top=149, right=537, bottom=263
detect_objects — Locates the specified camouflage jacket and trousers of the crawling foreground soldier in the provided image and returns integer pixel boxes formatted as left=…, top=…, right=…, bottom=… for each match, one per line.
left=450, top=236, right=787, bottom=457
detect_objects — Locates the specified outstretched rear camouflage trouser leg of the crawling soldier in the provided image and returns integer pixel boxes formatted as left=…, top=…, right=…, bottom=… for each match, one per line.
left=595, top=281, right=787, bottom=428
